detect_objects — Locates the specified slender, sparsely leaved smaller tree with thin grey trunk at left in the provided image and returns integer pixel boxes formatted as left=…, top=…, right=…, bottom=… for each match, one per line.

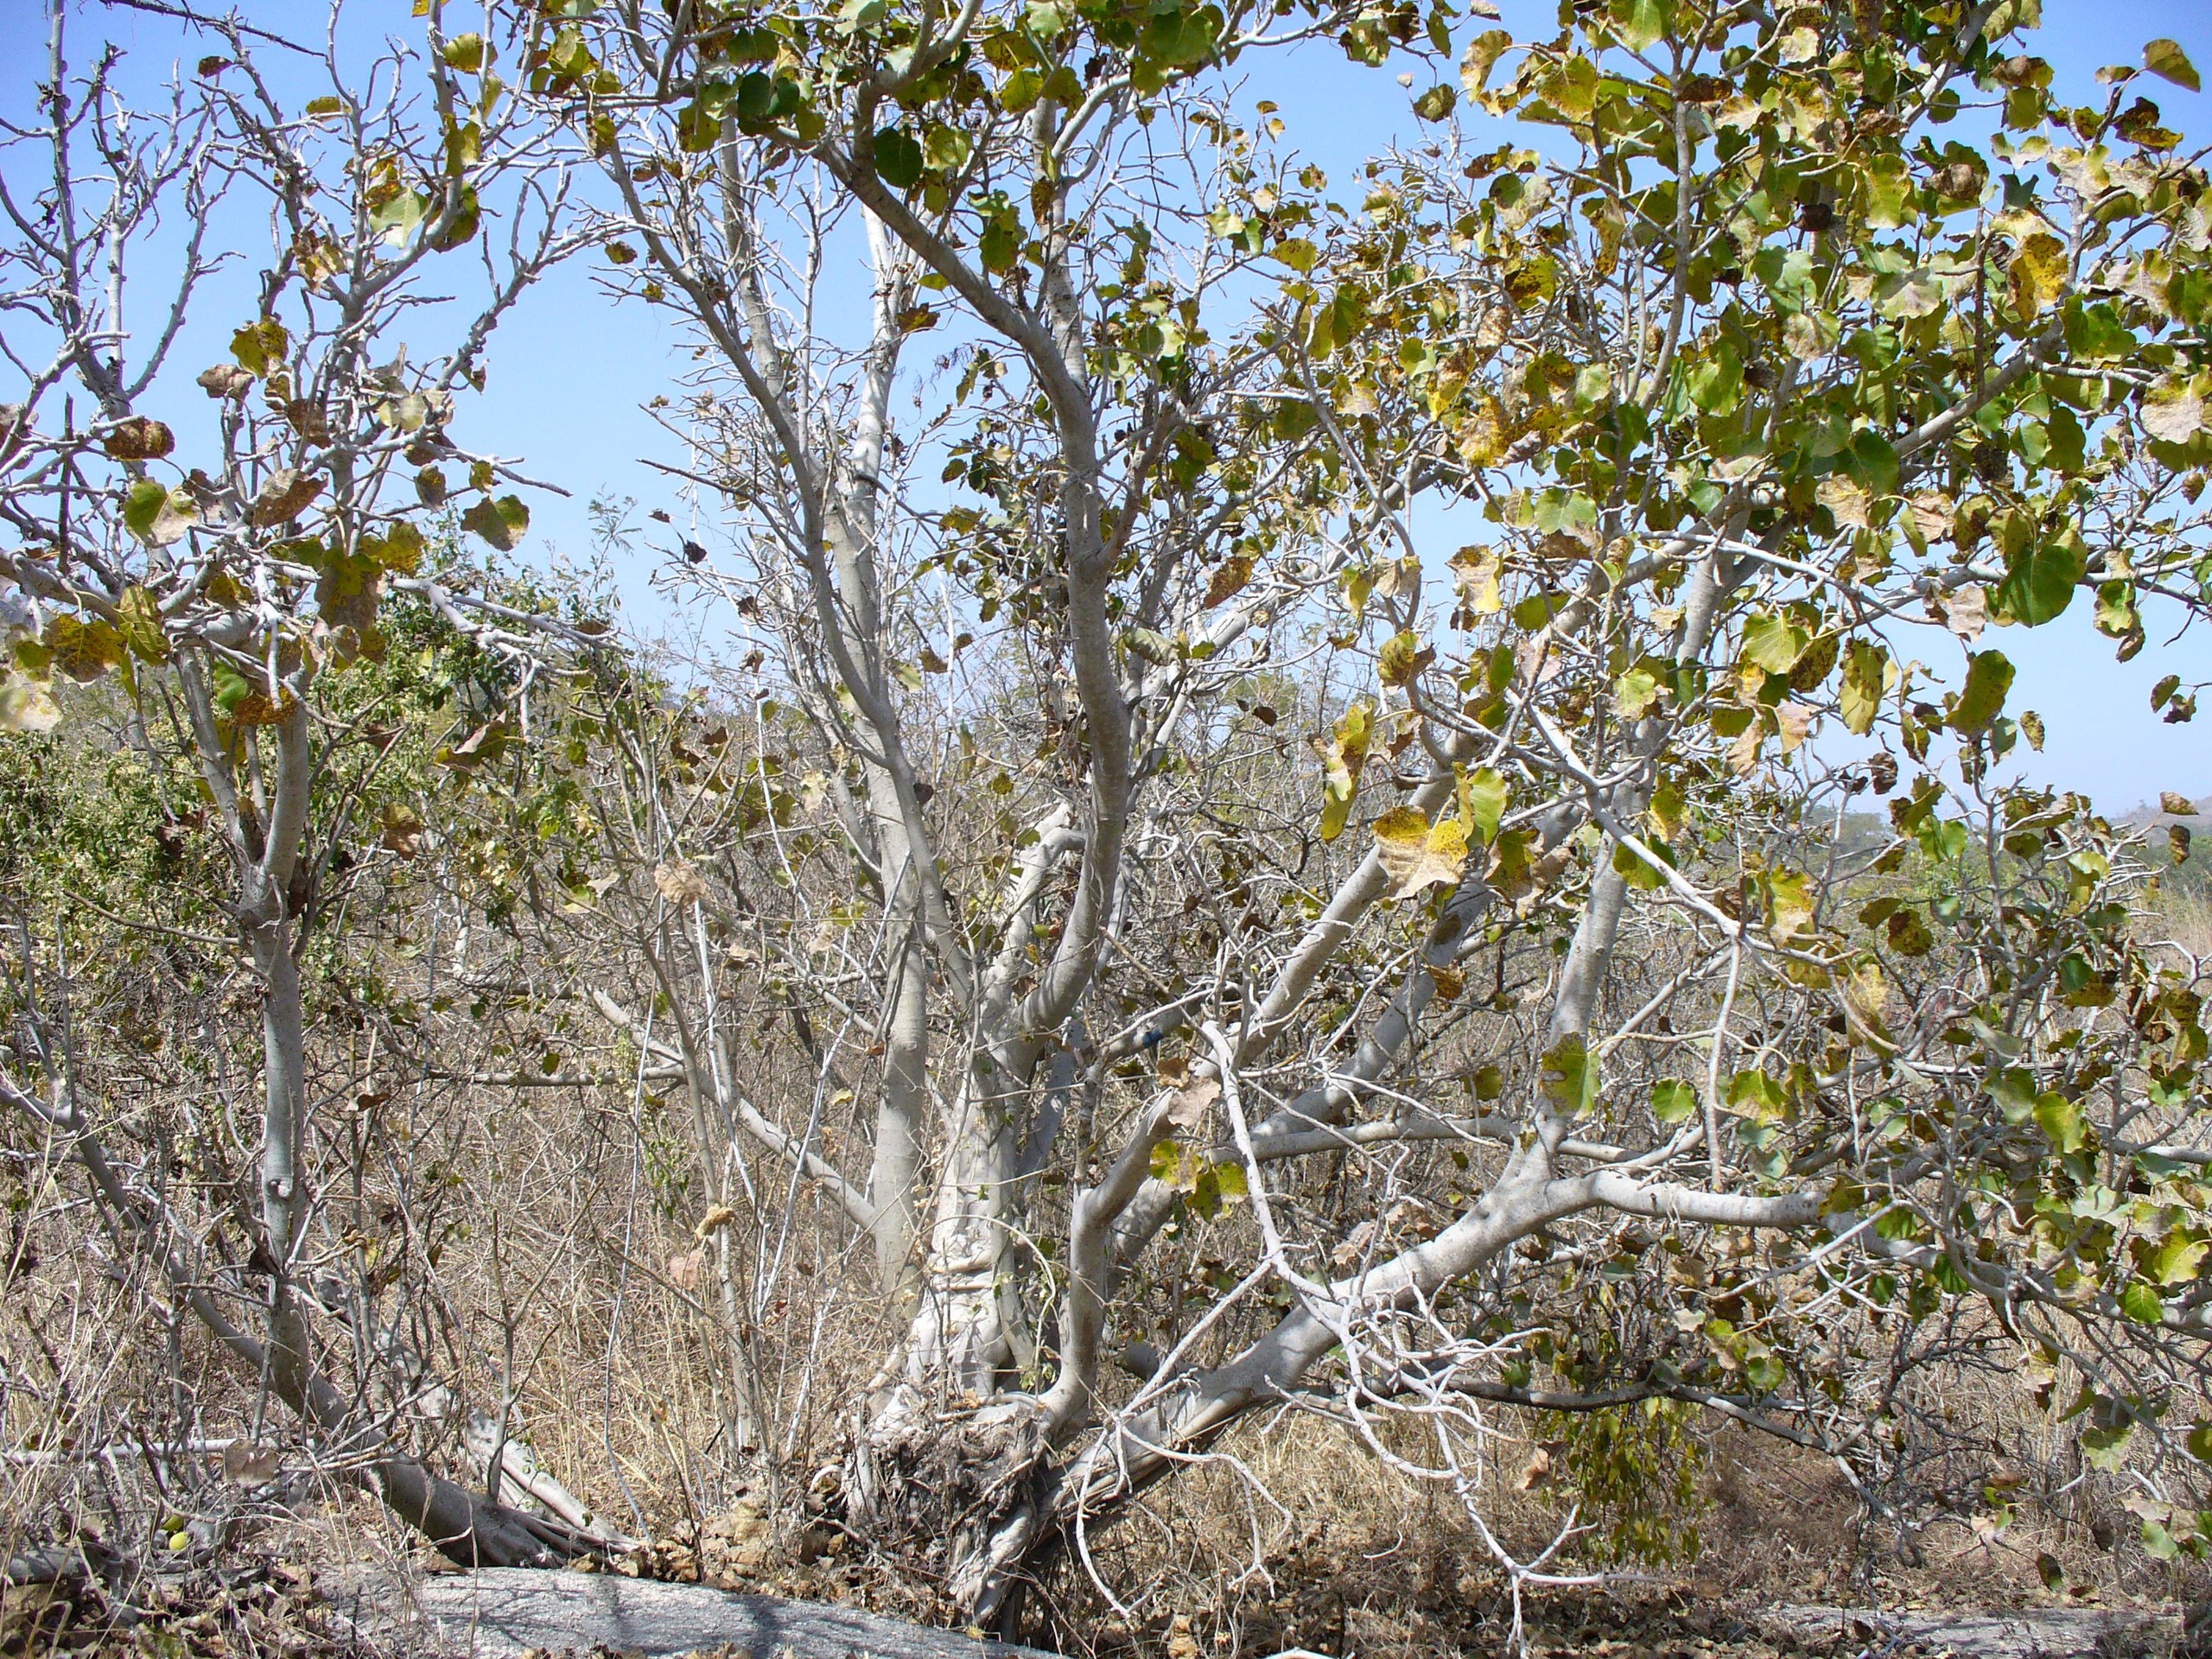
left=0, top=4, right=600, bottom=1564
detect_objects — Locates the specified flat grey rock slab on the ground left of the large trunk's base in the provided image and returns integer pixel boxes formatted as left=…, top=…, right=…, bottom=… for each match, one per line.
left=323, top=1568, right=1051, bottom=1659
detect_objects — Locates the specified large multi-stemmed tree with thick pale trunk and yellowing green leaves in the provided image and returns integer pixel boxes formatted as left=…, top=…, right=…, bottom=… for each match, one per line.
left=533, top=0, right=2212, bottom=1615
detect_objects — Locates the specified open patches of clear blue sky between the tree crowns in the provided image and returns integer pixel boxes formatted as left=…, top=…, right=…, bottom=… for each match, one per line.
left=0, top=0, right=2212, bottom=812
